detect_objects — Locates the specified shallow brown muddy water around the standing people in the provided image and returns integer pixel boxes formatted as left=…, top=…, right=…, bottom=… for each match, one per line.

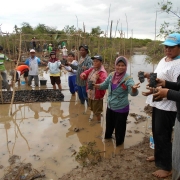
left=0, top=55, right=155, bottom=180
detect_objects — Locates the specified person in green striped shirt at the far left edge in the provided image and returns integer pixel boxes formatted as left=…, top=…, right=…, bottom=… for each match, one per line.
left=0, top=46, right=13, bottom=90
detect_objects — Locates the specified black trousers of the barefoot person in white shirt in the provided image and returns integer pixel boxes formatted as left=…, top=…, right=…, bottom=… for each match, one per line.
left=152, top=107, right=176, bottom=171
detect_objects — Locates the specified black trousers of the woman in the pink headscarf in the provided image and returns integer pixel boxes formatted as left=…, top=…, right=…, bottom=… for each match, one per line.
left=105, top=108, right=129, bottom=146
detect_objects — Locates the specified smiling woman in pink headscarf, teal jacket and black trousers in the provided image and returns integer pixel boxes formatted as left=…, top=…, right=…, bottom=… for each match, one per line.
left=95, top=56, right=139, bottom=146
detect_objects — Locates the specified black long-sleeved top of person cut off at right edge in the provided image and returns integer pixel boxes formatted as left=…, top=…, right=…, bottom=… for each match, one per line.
left=165, top=75, right=180, bottom=122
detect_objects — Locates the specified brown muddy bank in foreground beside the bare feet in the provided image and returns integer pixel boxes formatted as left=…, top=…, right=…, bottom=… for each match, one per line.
left=59, top=138, right=171, bottom=180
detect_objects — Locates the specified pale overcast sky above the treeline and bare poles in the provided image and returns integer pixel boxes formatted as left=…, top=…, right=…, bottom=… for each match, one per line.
left=0, top=0, right=180, bottom=39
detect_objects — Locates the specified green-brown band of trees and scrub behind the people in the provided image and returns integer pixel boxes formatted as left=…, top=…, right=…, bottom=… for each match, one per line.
left=0, top=22, right=163, bottom=63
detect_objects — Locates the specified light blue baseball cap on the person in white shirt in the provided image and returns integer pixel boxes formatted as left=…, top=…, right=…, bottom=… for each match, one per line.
left=162, top=33, right=180, bottom=46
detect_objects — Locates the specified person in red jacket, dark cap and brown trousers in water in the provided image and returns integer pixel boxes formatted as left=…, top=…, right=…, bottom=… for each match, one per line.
left=80, top=55, right=107, bottom=121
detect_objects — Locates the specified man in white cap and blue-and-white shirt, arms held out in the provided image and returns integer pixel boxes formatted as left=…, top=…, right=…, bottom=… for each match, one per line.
left=19, top=49, right=46, bottom=86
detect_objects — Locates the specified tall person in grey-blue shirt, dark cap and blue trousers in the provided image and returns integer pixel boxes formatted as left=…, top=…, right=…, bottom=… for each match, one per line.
left=76, top=44, right=92, bottom=104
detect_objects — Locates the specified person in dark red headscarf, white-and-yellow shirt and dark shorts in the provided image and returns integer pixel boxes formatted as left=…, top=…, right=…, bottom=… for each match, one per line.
left=46, top=51, right=62, bottom=90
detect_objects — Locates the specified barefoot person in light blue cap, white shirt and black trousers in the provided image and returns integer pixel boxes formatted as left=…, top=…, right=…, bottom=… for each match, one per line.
left=143, top=33, right=180, bottom=180
